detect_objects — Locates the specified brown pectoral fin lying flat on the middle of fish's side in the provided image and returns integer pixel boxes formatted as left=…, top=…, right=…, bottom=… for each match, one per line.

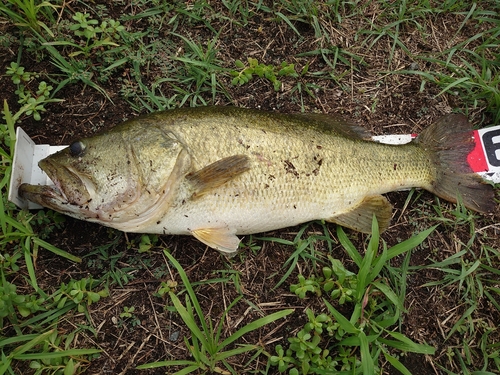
left=186, top=155, right=250, bottom=198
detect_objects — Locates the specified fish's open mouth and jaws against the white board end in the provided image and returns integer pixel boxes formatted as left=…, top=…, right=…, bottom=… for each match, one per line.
left=19, top=159, right=95, bottom=212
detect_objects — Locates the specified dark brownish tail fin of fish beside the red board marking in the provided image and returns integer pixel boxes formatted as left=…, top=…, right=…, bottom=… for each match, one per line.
left=416, top=114, right=496, bottom=212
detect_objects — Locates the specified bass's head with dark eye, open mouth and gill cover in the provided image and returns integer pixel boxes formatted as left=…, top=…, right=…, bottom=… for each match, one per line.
left=19, top=120, right=190, bottom=231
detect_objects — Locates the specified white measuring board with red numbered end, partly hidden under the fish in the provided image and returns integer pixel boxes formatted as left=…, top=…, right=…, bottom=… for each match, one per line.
left=8, top=125, right=500, bottom=209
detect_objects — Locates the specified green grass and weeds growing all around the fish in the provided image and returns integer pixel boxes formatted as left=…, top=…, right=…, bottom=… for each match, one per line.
left=0, top=0, right=500, bottom=375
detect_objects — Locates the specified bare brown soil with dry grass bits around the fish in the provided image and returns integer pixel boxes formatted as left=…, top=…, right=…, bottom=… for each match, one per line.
left=0, top=1, right=500, bottom=375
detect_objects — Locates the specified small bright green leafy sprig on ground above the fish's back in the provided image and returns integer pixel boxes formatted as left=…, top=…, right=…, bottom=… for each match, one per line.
left=230, top=57, right=298, bottom=91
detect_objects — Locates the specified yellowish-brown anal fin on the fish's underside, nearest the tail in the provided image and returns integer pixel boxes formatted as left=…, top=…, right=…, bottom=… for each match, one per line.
left=328, top=195, right=392, bottom=233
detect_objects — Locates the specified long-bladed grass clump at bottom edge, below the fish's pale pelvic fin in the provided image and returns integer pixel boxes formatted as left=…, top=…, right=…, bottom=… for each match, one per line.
left=137, top=251, right=293, bottom=375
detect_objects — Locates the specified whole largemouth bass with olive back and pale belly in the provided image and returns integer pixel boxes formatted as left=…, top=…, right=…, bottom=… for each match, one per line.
left=19, top=106, right=496, bottom=255
